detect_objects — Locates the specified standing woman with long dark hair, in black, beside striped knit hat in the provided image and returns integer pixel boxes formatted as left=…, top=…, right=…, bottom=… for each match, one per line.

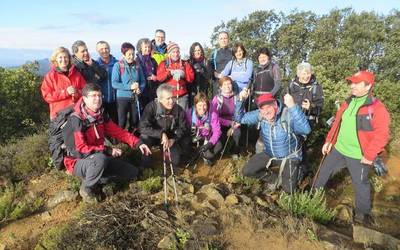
left=188, top=42, right=211, bottom=106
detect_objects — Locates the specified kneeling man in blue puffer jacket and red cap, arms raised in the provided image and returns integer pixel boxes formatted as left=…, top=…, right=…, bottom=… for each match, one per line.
left=235, top=91, right=311, bottom=193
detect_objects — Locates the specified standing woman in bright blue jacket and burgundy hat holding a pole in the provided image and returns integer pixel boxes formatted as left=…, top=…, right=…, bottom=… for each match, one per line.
left=112, top=42, right=146, bottom=131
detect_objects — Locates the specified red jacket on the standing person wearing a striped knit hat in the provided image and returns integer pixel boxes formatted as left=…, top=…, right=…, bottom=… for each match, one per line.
left=157, top=58, right=194, bottom=96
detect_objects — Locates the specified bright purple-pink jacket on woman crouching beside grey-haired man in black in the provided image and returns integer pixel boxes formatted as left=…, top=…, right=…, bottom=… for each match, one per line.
left=186, top=108, right=221, bottom=145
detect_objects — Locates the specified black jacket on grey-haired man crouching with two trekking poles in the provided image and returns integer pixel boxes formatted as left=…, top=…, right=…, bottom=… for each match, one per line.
left=139, top=100, right=189, bottom=140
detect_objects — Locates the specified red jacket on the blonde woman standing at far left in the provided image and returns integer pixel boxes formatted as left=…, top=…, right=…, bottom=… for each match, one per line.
left=41, top=65, right=86, bottom=119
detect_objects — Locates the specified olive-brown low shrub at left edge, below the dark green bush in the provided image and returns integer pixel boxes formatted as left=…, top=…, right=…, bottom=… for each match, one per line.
left=0, top=132, right=49, bottom=180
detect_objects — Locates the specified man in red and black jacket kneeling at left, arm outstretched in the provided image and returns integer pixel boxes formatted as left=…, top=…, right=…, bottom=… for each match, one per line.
left=63, top=83, right=151, bottom=202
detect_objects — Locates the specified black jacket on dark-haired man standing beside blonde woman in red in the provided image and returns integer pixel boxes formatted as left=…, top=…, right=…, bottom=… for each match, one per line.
left=72, top=56, right=108, bottom=86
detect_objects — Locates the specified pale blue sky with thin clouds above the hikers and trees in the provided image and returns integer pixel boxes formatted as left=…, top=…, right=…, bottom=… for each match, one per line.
left=0, top=0, right=400, bottom=65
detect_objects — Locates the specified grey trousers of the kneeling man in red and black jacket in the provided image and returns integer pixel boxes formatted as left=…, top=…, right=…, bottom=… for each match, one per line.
left=73, top=153, right=139, bottom=190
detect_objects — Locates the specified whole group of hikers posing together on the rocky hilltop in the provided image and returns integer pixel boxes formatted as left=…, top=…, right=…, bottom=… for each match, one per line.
left=41, top=29, right=390, bottom=225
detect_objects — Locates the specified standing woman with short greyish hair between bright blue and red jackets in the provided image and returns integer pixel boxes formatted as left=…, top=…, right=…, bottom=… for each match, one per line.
left=136, top=38, right=158, bottom=105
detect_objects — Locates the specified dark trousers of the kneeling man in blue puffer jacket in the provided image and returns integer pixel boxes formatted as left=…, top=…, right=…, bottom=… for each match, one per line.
left=242, top=152, right=299, bottom=193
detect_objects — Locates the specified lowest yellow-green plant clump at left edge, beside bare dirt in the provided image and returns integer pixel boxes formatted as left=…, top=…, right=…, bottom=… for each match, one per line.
left=0, top=182, right=44, bottom=222
